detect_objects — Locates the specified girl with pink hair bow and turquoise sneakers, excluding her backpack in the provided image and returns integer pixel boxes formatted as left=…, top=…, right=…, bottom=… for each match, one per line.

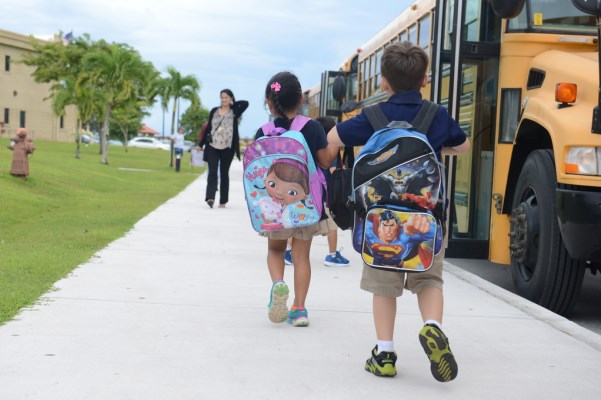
left=255, top=72, right=329, bottom=326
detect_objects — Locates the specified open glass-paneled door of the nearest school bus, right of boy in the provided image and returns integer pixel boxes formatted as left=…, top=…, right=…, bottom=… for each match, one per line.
left=432, top=0, right=501, bottom=259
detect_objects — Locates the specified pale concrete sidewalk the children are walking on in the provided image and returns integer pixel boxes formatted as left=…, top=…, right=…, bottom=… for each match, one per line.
left=0, top=161, right=601, bottom=400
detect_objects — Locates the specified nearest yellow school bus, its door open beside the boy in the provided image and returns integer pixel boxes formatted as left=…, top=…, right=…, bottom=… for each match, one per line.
left=321, top=0, right=601, bottom=314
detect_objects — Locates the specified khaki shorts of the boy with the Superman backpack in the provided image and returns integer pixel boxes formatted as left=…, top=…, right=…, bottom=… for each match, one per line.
left=361, top=247, right=444, bottom=297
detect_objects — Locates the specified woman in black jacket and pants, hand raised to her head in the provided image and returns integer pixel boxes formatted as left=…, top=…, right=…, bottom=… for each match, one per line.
left=200, top=89, right=248, bottom=208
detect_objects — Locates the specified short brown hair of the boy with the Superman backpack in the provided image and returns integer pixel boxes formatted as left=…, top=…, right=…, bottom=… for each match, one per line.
left=381, top=42, right=428, bottom=93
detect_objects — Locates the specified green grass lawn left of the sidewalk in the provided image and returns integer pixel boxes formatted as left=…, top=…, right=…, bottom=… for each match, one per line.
left=0, top=137, right=203, bottom=324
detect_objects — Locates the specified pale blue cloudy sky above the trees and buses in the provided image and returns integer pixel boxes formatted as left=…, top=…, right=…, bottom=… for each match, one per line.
left=0, top=0, right=413, bottom=137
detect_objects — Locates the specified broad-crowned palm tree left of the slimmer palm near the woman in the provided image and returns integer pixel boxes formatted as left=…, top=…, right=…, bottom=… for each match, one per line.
left=78, top=40, right=154, bottom=164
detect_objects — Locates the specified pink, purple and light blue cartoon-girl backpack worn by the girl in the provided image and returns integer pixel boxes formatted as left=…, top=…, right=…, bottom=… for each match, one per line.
left=242, top=115, right=326, bottom=232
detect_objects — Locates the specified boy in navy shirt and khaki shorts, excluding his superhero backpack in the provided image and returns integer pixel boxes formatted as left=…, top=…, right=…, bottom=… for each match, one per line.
left=328, top=42, right=470, bottom=382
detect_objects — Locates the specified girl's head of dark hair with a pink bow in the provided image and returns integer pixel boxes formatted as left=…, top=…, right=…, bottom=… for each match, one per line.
left=265, top=71, right=303, bottom=123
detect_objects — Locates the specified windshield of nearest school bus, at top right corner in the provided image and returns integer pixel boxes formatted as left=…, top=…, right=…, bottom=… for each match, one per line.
left=507, top=0, right=597, bottom=35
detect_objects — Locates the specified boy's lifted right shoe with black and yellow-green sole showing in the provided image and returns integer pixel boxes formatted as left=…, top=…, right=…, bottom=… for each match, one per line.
left=419, top=324, right=458, bottom=382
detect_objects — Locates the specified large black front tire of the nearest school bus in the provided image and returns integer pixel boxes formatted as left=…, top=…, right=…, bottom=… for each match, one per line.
left=510, top=149, right=585, bottom=315
